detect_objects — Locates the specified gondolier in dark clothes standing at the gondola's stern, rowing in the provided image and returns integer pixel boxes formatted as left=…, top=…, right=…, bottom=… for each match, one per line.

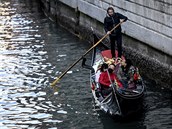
left=104, top=7, right=128, bottom=58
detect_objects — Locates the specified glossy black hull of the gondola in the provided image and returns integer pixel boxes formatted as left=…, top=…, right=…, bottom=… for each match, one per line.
left=83, top=35, right=144, bottom=120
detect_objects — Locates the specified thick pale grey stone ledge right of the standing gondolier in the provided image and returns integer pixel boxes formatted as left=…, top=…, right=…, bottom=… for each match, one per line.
left=123, top=21, right=172, bottom=56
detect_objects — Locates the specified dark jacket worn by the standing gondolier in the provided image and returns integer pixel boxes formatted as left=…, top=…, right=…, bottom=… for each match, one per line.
left=104, top=13, right=128, bottom=36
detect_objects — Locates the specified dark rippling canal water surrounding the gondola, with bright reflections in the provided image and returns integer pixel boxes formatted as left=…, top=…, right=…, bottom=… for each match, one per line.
left=0, top=0, right=172, bottom=129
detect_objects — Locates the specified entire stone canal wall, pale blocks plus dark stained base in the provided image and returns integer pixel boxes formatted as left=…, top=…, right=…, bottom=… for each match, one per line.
left=40, top=0, right=172, bottom=86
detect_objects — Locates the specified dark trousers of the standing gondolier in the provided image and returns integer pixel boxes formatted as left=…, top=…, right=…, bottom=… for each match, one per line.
left=110, top=33, right=122, bottom=58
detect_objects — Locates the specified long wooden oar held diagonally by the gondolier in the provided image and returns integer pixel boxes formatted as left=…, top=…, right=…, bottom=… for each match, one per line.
left=51, top=20, right=124, bottom=86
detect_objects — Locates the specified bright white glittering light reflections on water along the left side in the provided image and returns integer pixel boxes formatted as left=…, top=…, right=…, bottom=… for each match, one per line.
left=0, top=1, right=56, bottom=128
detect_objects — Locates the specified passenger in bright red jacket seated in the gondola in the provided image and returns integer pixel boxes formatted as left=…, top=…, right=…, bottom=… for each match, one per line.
left=99, top=65, right=121, bottom=96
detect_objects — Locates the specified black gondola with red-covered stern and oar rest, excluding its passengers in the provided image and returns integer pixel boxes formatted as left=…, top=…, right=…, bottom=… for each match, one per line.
left=82, top=34, right=145, bottom=120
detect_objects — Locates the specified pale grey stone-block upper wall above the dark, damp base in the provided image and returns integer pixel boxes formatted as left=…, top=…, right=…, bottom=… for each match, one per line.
left=57, top=0, right=172, bottom=56
